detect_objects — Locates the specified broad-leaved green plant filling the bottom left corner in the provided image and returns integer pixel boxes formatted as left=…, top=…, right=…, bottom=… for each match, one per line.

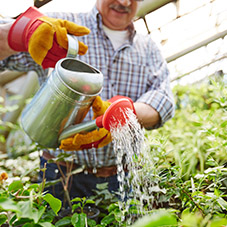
left=0, top=180, right=61, bottom=227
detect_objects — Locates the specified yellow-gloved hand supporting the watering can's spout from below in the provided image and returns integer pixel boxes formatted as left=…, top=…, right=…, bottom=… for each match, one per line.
left=60, top=96, right=112, bottom=151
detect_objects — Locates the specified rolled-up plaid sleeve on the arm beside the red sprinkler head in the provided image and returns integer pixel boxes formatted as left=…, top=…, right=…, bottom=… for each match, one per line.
left=137, top=41, right=175, bottom=130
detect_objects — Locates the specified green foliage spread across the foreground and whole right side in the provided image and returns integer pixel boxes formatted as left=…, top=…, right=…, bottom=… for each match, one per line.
left=0, top=81, right=227, bottom=227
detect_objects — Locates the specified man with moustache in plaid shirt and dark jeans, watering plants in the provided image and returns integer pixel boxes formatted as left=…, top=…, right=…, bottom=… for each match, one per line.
left=0, top=0, right=174, bottom=205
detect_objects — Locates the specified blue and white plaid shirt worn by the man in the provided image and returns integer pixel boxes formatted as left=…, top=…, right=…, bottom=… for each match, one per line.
left=0, top=7, right=174, bottom=167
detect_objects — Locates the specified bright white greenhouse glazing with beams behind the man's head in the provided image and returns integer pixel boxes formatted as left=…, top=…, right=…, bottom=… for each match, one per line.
left=0, top=0, right=227, bottom=86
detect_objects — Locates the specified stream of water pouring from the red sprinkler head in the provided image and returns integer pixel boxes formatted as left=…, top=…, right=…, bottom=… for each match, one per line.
left=111, top=109, right=150, bottom=224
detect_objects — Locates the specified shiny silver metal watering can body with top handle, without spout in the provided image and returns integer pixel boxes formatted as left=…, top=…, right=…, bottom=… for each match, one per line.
left=21, top=35, right=103, bottom=148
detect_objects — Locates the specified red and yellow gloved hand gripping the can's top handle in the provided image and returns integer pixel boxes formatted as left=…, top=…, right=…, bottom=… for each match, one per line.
left=8, top=7, right=90, bottom=68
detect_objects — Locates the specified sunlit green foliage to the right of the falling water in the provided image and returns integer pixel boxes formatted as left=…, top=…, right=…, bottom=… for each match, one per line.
left=138, top=81, right=227, bottom=226
